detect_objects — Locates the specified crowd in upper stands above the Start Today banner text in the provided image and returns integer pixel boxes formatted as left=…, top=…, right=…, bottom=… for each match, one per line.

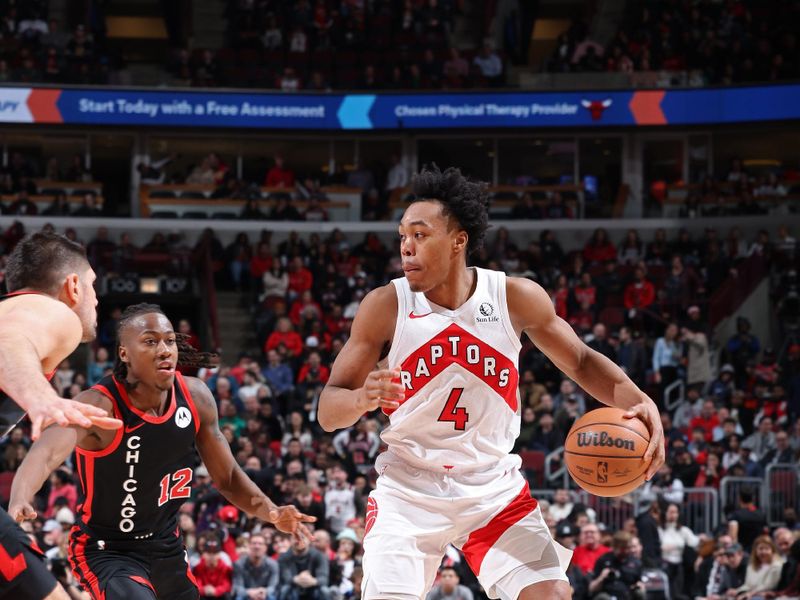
left=169, top=0, right=504, bottom=92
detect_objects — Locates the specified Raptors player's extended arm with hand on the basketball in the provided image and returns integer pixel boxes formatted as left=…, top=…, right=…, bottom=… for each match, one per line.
left=506, top=277, right=665, bottom=479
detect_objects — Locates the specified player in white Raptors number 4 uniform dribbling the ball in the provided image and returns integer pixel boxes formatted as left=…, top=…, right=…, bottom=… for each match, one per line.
left=319, top=167, right=664, bottom=600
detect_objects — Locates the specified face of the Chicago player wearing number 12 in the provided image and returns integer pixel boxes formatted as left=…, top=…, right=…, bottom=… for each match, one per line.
left=120, top=313, right=178, bottom=391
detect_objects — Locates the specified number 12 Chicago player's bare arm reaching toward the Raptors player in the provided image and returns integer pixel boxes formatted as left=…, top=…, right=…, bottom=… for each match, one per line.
left=186, top=377, right=317, bottom=538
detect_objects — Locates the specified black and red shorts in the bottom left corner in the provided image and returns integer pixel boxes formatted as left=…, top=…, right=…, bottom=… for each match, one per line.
left=0, top=509, right=57, bottom=600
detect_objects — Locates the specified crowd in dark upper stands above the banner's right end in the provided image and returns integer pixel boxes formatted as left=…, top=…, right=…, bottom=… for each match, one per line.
left=546, top=0, right=800, bottom=86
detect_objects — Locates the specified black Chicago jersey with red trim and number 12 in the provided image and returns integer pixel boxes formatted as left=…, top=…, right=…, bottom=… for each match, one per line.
left=76, top=373, right=200, bottom=541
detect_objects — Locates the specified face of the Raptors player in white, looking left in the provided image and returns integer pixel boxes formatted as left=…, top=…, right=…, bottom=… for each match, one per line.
left=398, top=200, right=467, bottom=292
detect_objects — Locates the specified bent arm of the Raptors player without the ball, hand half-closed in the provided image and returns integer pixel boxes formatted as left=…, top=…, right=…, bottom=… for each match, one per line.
left=317, top=284, right=403, bottom=431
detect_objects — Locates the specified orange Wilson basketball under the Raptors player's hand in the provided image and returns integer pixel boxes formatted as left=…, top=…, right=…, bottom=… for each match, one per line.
left=564, top=407, right=650, bottom=496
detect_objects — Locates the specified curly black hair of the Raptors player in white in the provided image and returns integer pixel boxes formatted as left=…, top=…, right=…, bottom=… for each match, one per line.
left=411, top=164, right=489, bottom=254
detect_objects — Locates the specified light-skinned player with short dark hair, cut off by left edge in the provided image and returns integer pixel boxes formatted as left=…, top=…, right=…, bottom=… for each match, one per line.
left=0, top=233, right=121, bottom=600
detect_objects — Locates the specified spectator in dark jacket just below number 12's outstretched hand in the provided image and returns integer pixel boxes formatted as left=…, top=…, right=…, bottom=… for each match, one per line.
left=277, top=536, right=330, bottom=600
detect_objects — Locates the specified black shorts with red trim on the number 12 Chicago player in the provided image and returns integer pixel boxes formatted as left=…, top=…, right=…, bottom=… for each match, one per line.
left=69, top=526, right=200, bottom=600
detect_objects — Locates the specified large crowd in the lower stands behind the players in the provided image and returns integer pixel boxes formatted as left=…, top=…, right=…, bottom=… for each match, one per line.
left=0, top=218, right=800, bottom=600
